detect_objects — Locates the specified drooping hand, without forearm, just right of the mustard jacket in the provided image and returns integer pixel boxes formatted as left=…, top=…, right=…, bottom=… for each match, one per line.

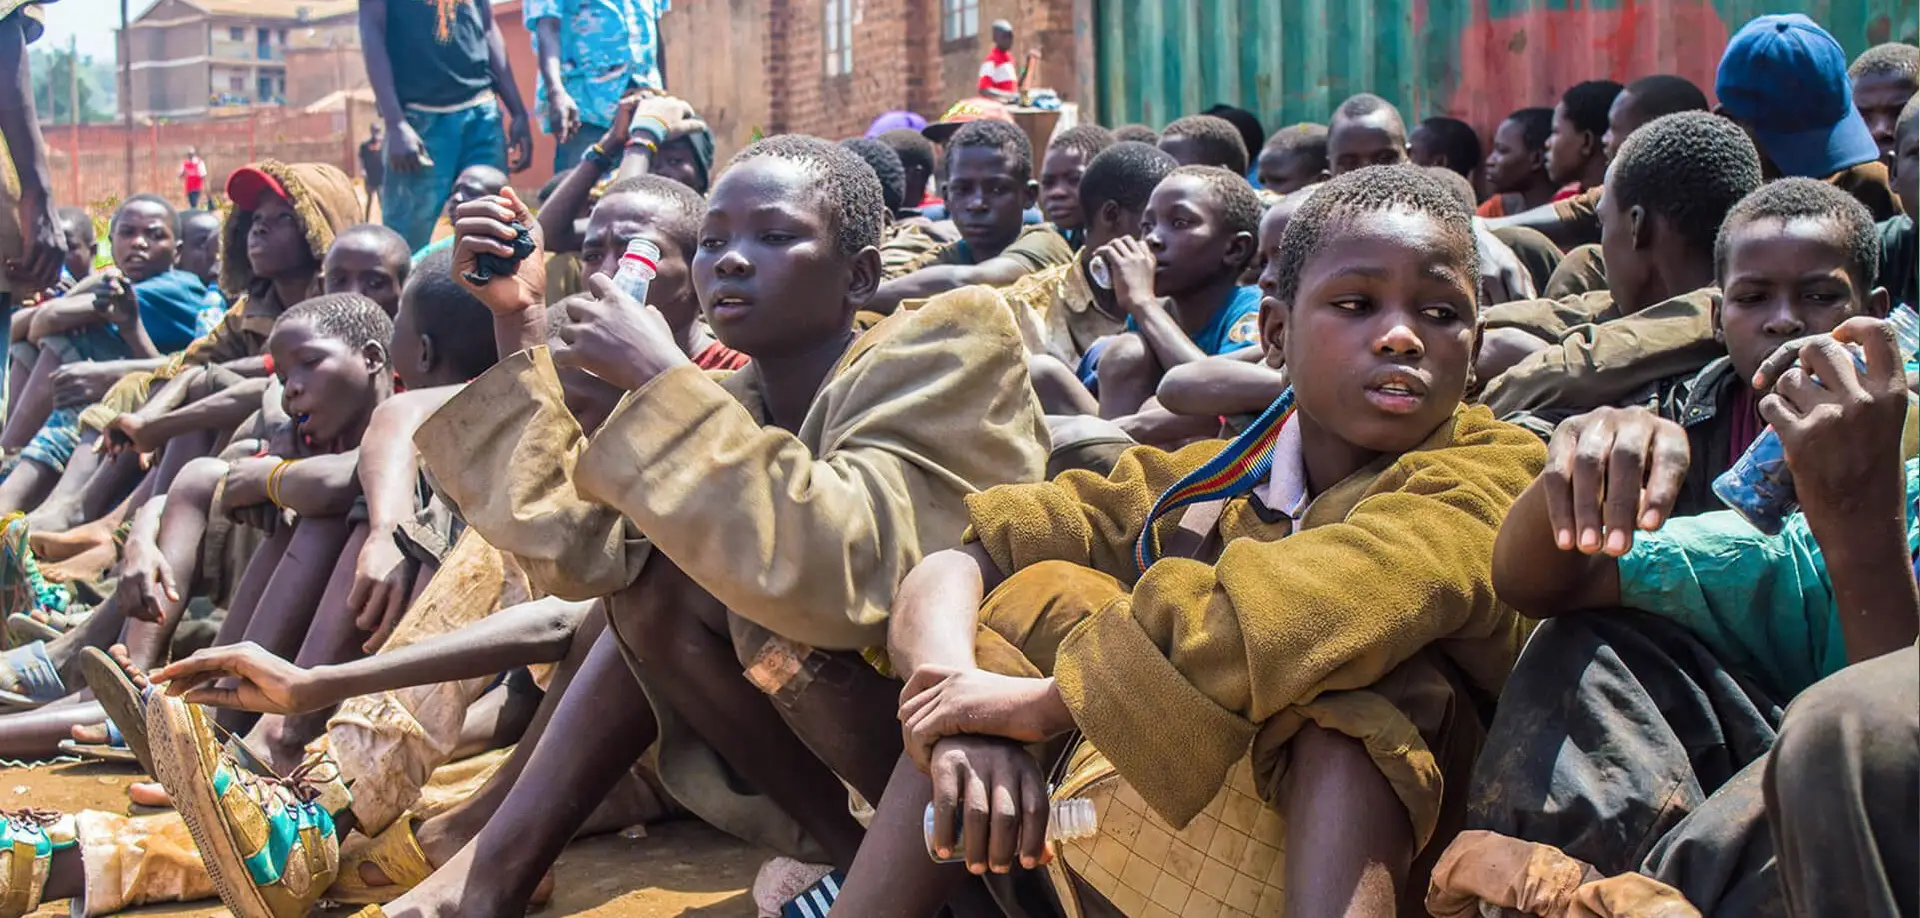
left=1540, top=407, right=1692, bottom=557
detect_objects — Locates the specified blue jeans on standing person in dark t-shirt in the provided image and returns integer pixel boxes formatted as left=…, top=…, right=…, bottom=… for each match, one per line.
left=380, top=98, right=507, bottom=250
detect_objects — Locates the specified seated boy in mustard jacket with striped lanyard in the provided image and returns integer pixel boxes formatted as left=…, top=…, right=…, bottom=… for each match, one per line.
left=841, top=167, right=1544, bottom=914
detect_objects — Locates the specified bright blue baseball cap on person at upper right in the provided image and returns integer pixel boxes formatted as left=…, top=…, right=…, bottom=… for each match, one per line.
left=1713, top=13, right=1880, bottom=179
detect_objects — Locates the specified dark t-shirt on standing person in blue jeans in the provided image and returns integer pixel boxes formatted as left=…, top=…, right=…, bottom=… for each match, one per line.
left=386, top=0, right=493, bottom=108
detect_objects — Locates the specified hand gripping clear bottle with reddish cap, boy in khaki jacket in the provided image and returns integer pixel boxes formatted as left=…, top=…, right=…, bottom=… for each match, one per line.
left=553, top=275, right=687, bottom=392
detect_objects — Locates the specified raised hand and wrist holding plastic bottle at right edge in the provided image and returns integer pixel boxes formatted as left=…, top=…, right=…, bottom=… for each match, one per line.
left=1753, top=317, right=1907, bottom=522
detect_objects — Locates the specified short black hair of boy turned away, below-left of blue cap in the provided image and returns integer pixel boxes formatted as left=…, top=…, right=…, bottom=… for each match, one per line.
left=1607, top=111, right=1763, bottom=252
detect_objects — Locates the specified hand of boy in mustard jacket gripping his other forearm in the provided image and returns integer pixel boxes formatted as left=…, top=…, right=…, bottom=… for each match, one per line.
left=900, top=666, right=1073, bottom=768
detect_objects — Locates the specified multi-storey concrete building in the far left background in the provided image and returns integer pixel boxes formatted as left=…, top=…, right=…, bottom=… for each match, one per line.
left=119, top=0, right=365, bottom=121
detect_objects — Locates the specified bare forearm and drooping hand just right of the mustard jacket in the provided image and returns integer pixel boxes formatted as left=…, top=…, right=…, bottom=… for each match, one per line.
left=1494, top=407, right=1688, bottom=618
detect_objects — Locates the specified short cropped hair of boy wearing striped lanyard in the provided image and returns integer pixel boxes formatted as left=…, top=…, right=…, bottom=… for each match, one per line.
left=1273, top=165, right=1480, bottom=303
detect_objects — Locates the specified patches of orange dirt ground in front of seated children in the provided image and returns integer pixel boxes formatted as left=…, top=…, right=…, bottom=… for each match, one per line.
left=0, top=764, right=766, bottom=918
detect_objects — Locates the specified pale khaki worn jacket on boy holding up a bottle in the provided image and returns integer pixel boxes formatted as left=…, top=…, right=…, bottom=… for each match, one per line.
left=415, top=288, right=1048, bottom=649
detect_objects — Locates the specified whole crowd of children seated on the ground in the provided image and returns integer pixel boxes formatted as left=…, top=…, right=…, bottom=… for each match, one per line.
left=0, top=10, right=1920, bottom=918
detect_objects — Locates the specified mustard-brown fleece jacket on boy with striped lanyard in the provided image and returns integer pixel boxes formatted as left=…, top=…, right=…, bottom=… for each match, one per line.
left=968, top=407, right=1546, bottom=843
